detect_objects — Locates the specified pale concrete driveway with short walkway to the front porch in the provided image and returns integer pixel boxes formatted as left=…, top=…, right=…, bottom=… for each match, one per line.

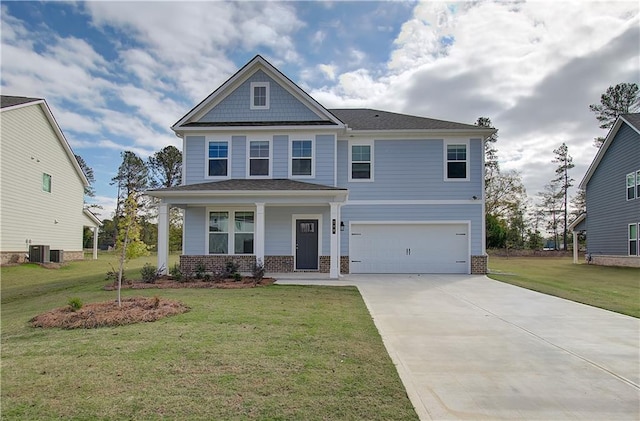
left=274, top=274, right=640, bottom=420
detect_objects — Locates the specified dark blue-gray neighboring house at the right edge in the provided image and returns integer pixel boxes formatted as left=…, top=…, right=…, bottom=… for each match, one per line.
left=570, top=113, right=640, bottom=267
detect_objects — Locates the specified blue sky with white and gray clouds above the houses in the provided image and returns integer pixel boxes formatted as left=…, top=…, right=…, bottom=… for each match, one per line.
left=0, top=0, right=640, bottom=218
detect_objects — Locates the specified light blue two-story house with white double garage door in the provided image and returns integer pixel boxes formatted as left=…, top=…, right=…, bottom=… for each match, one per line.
left=148, top=56, right=494, bottom=278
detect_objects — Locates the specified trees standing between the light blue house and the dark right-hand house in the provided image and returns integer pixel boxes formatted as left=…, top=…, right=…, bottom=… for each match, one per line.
left=476, top=83, right=640, bottom=250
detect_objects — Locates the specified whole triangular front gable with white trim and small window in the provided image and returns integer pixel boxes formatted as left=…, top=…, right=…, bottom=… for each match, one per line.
left=172, top=55, right=344, bottom=134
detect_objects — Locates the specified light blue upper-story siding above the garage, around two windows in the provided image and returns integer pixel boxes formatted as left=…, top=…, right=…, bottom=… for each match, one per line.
left=338, top=139, right=483, bottom=200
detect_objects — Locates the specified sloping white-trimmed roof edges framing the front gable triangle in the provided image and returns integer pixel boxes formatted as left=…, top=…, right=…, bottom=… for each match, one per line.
left=171, top=55, right=342, bottom=131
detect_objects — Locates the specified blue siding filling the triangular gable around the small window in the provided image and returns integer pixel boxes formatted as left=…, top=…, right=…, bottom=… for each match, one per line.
left=199, top=70, right=322, bottom=122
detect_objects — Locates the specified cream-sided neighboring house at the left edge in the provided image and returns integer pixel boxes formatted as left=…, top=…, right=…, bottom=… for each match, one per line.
left=0, top=95, right=101, bottom=264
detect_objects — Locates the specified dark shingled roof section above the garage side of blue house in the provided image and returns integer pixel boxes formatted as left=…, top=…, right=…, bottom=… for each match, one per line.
left=329, top=108, right=494, bottom=131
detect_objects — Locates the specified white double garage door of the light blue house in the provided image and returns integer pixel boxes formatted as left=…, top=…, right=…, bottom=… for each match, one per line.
left=349, top=223, right=469, bottom=273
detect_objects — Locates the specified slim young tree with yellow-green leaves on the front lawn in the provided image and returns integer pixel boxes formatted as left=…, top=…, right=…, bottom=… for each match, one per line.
left=116, top=193, right=149, bottom=307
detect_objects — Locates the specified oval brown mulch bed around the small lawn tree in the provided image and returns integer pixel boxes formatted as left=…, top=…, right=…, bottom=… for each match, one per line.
left=29, top=297, right=190, bottom=329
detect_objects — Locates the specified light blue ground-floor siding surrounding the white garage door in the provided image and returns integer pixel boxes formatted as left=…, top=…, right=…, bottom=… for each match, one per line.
left=340, top=204, right=482, bottom=256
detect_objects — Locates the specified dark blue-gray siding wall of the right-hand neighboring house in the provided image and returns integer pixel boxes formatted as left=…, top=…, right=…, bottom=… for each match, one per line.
left=586, top=124, right=640, bottom=256
